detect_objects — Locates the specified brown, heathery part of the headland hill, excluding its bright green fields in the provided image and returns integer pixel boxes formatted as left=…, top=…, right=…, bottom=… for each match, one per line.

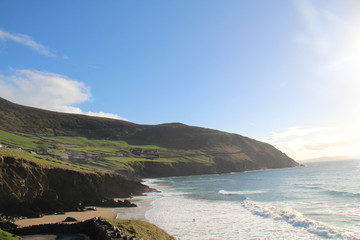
left=0, top=95, right=298, bottom=177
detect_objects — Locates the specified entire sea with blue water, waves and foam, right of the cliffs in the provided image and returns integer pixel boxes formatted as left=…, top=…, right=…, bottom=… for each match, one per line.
left=145, top=160, right=360, bottom=240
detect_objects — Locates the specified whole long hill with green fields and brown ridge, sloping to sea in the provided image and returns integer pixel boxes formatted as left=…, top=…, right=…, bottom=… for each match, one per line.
left=0, top=98, right=298, bottom=177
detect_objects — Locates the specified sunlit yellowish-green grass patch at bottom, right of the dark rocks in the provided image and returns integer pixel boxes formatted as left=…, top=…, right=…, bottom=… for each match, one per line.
left=106, top=218, right=175, bottom=240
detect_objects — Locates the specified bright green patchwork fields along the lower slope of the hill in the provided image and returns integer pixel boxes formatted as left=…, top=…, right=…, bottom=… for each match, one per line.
left=0, top=130, right=210, bottom=171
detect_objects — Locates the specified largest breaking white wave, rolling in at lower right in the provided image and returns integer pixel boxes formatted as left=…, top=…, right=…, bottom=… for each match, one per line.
left=242, top=200, right=360, bottom=240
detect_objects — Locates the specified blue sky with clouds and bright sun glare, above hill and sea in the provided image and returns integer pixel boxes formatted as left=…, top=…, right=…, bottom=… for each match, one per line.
left=0, top=0, right=360, bottom=160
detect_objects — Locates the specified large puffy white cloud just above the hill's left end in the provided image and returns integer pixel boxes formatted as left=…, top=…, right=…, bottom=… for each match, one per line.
left=0, top=70, right=126, bottom=120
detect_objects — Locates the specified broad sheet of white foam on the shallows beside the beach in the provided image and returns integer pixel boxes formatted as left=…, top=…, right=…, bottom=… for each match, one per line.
left=145, top=179, right=344, bottom=240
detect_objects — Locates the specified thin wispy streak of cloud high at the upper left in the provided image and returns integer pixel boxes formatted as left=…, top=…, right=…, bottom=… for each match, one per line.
left=0, top=29, right=55, bottom=57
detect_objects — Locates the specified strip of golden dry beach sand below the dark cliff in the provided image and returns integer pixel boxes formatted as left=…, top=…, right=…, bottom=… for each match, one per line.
left=15, top=207, right=116, bottom=227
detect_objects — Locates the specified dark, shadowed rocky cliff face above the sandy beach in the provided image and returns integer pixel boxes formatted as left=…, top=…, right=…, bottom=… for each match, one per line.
left=0, top=157, right=147, bottom=216
